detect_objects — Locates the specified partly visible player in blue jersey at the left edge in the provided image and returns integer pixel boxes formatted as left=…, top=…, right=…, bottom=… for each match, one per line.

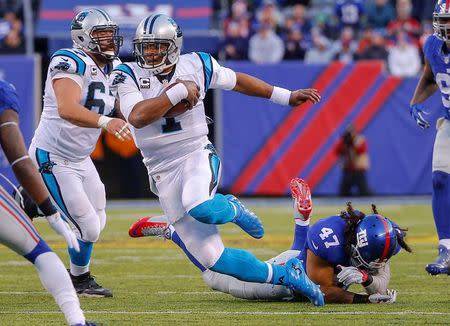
left=0, top=80, right=93, bottom=326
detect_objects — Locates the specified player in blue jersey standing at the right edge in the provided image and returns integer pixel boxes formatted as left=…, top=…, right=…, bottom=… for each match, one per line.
left=410, top=0, right=450, bottom=275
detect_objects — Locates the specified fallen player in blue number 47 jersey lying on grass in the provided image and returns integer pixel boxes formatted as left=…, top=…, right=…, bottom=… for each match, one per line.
left=129, top=179, right=411, bottom=303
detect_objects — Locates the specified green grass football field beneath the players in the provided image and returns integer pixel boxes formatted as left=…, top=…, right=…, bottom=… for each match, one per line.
left=0, top=205, right=450, bottom=326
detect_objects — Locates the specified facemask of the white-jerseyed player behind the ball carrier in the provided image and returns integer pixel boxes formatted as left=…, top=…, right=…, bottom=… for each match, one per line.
left=88, top=25, right=123, bottom=61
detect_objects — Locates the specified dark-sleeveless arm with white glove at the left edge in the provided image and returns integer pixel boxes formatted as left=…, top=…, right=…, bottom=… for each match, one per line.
left=0, top=109, right=80, bottom=251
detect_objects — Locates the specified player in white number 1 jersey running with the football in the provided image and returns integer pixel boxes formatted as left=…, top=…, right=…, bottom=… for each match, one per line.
left=110, top=14, right=324, bottom=305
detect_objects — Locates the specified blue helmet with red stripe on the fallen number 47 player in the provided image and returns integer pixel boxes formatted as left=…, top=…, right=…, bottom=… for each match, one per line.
left=351, top=214, right=398, bottom=270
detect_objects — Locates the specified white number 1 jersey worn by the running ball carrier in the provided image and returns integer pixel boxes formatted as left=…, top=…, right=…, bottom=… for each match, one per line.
left=110, top=52, right=236, bottom=173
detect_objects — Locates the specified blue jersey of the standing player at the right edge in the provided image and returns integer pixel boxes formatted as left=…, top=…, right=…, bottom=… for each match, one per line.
left=423, top=35, right=450, bottom=120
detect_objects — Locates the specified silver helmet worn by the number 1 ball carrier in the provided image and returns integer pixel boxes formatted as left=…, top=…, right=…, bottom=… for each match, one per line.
left=133, top=14, right=183, bottom=75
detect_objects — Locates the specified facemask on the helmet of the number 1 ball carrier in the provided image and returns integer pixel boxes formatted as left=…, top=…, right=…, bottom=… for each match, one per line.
left=133, top=38, right=179, bottom=75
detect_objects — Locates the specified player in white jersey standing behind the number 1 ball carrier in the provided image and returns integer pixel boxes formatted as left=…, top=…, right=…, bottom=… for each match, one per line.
left=29, top=8, right=131, bottom=297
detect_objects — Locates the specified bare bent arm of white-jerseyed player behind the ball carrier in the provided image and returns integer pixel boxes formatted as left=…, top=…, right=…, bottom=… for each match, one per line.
left=53, top=78, right=131, bottom=140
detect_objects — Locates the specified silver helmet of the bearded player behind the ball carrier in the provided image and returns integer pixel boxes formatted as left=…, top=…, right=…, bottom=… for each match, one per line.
left=70, top=8, right=123, bottom=61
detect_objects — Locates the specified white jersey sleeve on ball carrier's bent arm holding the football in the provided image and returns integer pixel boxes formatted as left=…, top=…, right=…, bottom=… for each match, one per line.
left=110, top=70, right=144, bottom=121
